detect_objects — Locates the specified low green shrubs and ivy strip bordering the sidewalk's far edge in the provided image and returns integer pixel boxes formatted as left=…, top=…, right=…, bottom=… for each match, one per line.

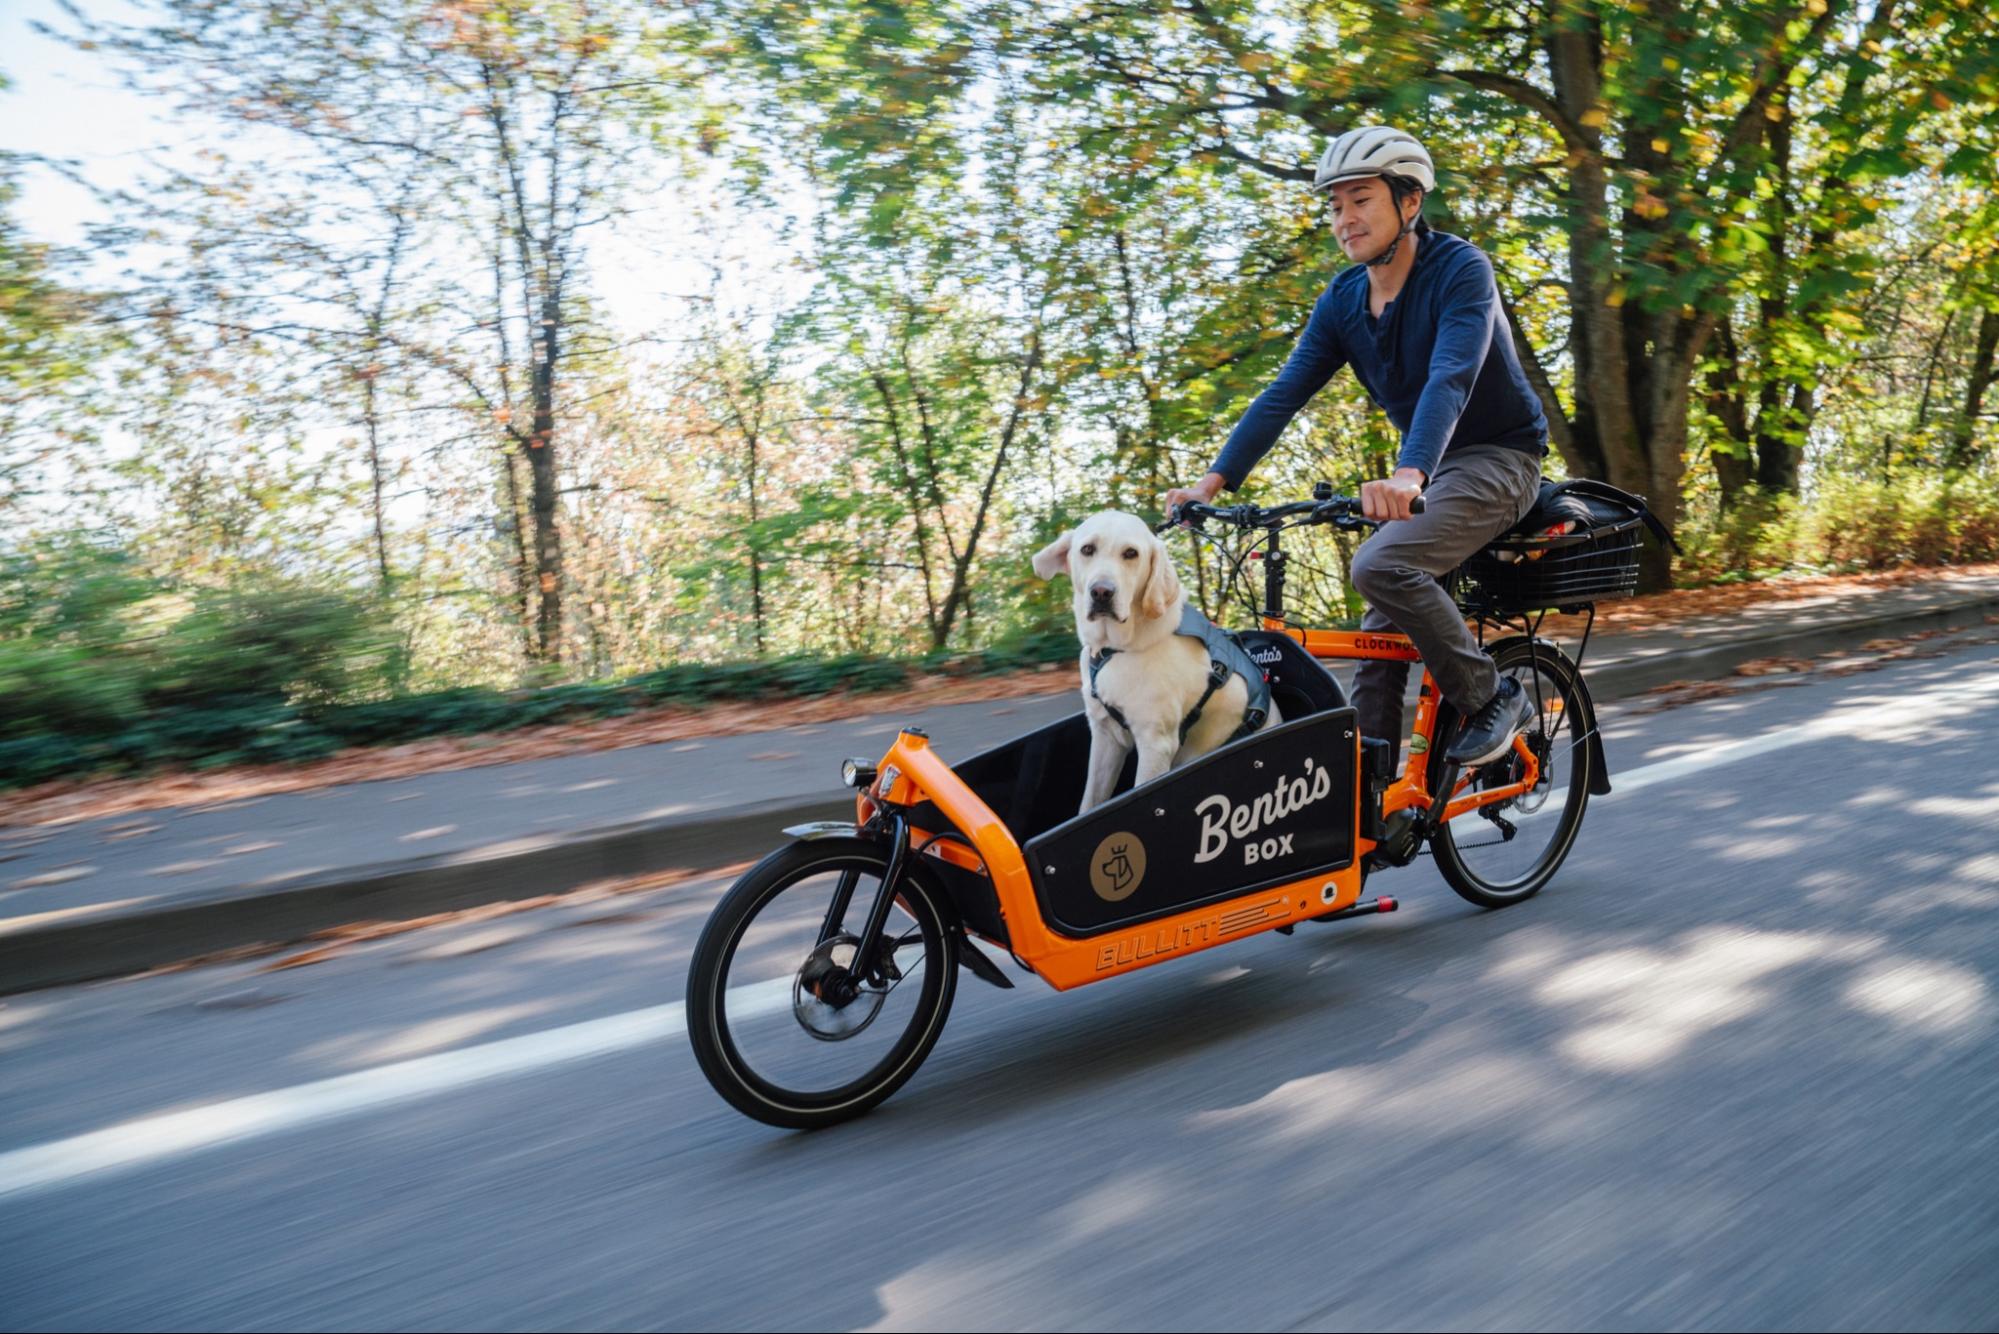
left=0, top=540, right=1075, bottom=786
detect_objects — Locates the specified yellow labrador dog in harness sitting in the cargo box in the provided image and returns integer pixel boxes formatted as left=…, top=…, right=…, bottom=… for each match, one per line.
left=1033, top=510, right=1281, bottom=814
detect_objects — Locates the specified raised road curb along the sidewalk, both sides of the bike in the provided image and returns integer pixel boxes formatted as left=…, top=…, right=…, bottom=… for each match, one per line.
left=0, top=594, right=1999, bottom=994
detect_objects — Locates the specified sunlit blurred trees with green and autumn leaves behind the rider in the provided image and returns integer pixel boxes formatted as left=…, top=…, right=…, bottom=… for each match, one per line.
left=0, top=0, right=1999, bottom=772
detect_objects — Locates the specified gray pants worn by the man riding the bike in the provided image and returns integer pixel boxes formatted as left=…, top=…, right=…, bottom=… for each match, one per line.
left=1353, top=444, right=1541, bottom=768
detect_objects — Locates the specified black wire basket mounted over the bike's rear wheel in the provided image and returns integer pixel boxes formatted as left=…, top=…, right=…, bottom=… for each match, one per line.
left=1451, top=516, right=1645, bottom=616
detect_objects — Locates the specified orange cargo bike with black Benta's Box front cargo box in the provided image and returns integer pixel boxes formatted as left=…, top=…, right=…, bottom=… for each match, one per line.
left=686, top=484, right=1639, bottom=1128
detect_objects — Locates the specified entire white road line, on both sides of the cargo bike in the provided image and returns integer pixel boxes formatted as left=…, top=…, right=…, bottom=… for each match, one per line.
left=15, top=672, right=1999, bottom=1200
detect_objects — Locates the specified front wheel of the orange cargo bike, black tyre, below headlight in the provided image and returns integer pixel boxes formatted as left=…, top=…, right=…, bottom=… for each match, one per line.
left=688, top=838, right=958, bottom=1130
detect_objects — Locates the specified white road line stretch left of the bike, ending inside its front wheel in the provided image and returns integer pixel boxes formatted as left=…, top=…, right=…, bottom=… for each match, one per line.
left=0, top=978, right=792, bottom=1200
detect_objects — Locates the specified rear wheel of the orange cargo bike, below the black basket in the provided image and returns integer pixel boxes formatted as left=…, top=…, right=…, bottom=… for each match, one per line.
left=1429, top=640, right=1593, bottom=908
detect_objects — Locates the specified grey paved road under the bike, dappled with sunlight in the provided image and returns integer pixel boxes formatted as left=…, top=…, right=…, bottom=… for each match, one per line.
left=0, top=646, right=1999, bottom=1330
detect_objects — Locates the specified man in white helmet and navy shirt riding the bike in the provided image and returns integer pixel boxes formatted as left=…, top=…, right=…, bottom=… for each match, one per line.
left=1165, top=126, right=1547, bottom=766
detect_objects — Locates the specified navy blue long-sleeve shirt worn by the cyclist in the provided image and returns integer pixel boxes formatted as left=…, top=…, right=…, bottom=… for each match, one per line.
left=1211, top=232, right=1547, bottom=490
